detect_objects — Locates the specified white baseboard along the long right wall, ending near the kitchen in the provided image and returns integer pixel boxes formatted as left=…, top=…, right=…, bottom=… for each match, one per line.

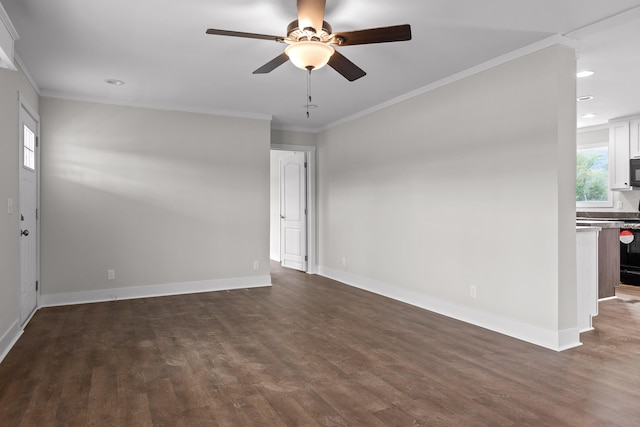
left=318, top=266, right=582, bottom=351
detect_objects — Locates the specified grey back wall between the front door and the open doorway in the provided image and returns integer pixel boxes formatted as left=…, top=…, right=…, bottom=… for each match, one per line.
left=41, top=98, right=270, bottom=303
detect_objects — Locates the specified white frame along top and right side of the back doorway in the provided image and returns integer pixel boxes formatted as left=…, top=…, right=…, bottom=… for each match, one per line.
left=271, top=144, right=318, bottom=274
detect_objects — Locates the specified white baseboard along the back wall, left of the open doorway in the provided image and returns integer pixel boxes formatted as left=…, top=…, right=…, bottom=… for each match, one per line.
left=41, top=276, right=271, bottom=307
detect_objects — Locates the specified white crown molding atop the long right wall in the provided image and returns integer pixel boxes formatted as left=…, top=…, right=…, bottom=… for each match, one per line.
left=316, top=35, right=577, bottom=132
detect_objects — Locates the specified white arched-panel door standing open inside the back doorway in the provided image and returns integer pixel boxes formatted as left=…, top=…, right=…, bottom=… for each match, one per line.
left=280, top=152, right=307, bottom=271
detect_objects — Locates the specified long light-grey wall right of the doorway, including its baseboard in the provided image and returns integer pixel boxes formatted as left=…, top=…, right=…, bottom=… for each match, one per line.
left=318, top=46, right=578, bottom=349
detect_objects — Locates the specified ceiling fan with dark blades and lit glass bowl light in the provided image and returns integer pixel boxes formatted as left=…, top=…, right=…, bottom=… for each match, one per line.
left=207, top=0, right=411, bottom=81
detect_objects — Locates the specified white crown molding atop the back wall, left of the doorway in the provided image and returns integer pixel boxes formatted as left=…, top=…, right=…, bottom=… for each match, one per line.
left=41, top=90, right=273, bottom=121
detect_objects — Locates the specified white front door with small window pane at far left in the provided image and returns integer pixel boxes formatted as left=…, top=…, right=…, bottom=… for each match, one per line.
left=19, top=104, right=39, bottom=325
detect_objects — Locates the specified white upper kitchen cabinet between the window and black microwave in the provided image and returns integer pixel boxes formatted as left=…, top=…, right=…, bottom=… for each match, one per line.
left=609, top=121, right=631, bottom=191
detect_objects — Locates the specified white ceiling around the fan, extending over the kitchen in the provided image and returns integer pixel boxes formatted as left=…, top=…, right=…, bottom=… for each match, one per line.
left=0, top=0, right=640, bottom=131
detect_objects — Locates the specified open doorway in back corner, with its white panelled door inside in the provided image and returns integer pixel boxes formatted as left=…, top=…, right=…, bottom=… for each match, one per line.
left=270, top=144, right=317, bottom=274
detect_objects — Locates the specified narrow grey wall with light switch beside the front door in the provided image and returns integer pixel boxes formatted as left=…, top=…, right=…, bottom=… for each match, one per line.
left=0, top=63, right=38, bottom=360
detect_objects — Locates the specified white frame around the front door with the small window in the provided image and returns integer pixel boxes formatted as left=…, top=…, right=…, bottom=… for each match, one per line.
left=15, top=92, right=42, bottom=328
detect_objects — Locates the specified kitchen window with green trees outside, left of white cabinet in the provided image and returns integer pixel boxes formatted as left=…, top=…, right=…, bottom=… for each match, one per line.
left=576, top=142, right=613, bottom=208
